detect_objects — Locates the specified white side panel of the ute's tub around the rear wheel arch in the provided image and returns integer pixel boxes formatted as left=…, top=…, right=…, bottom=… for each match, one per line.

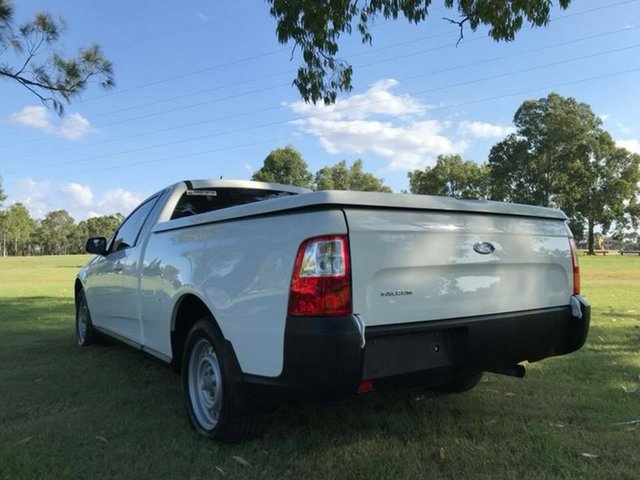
left=141, top=208, right=347, bottom=377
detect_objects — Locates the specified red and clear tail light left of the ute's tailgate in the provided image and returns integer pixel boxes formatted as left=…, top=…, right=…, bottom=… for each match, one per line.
left=289, top=235, right=351, bottom=317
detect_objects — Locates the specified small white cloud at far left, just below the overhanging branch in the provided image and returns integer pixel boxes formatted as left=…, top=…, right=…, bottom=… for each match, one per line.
left=9, top=105, right=95, bottom=140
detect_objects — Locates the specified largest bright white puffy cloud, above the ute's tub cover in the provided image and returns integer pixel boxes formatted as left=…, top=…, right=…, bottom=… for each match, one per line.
left=288, top=79, right=466, bottom=170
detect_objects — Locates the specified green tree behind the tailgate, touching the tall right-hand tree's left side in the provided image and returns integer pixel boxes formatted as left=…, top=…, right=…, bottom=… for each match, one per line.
left=409, top=155, right=489, bottom=198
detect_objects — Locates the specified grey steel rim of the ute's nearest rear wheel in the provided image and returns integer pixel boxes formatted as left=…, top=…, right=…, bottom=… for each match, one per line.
left=188, top=338, right=222, bottom=430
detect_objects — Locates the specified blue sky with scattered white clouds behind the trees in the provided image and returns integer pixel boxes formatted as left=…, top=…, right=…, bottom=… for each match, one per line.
left=0, top=0, right=640, bottom=220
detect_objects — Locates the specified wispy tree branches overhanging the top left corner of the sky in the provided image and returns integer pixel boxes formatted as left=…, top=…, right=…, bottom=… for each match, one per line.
left=0, top=0, right=115, bottom=115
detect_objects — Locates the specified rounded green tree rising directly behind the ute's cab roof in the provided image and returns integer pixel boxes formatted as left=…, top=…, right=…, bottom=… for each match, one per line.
left=251, top=145, right=313, bottom=188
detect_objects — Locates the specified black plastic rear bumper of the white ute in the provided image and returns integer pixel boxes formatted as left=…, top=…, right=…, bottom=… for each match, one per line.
left=242, top=296, right=591, bottom=403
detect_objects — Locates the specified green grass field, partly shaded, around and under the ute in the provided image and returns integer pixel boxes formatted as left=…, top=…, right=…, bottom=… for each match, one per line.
left=0, top=256, right=640, bottom=480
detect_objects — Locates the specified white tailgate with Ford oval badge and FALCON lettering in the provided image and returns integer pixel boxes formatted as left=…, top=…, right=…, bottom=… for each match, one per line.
left=344, top=207, right=573, bottom=326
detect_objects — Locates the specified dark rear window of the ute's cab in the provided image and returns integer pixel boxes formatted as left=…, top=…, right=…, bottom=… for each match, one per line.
left=171, top=188, right=295, bottom=220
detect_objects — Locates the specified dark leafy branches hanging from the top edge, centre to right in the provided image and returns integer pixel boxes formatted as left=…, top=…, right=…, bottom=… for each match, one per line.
left=268, top=0, right=571, bottom=104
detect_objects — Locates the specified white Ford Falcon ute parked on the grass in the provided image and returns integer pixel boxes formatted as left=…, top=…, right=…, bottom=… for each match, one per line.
left=75, top=180, right=590, bottom=440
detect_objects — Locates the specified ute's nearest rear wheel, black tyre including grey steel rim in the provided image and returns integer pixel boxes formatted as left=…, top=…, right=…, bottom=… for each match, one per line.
left=182, top=318, right=259, bottom=442
